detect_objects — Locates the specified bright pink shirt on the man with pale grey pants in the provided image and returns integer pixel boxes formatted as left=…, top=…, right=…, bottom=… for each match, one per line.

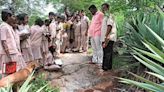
left=88, top=11, right=104, bottom=37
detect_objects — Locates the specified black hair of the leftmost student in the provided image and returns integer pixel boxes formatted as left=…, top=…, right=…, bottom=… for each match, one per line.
left=1, top=9, right=13, bottom=21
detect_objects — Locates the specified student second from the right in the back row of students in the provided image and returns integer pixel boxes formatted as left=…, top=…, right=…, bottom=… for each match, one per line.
left=74, top=16, right=81, bottom=52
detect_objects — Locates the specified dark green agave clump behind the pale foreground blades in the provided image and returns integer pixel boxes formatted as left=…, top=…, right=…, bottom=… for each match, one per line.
left=124, top=8, right=164, bottom=50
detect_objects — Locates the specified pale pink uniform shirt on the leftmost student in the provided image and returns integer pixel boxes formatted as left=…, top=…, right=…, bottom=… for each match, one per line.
left=0, top=22, right=19, bottom=54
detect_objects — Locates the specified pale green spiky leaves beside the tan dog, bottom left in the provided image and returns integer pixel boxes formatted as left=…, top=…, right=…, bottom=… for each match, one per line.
left=0, top=72, right=47, bottom=92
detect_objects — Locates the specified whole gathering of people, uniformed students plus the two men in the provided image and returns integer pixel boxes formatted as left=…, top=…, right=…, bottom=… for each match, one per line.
left=0, top=3, right=117, bottom=77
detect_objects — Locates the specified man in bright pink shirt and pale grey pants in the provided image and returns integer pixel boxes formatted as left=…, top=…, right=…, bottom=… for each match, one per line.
left=88, top=5, right=104, bottom=64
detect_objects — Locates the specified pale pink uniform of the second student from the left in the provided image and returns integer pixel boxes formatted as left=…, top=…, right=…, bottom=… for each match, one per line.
left=18, top=25, right=34, bottom=63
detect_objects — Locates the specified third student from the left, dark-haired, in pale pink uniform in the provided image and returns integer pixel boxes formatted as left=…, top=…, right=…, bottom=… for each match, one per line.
left=30, top=18, right=44, bottom=64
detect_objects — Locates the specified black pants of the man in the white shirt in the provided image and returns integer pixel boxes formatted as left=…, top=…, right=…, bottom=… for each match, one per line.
left=102, top=41, right=114, bottom=70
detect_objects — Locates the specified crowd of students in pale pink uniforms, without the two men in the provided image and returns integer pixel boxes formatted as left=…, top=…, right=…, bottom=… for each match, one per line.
left=0, top=5, right=89, bottom=76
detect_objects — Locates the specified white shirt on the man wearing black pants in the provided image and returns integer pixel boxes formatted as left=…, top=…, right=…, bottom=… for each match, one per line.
left=101, top=14, right=117, bottom=42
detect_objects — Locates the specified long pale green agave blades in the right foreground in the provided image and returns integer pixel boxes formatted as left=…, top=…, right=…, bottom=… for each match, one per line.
left=119, top=8, right=164, bottom=92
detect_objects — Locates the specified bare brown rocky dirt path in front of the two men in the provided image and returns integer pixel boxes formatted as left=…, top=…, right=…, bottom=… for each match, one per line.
left=45, top=53, right=118, bottom=92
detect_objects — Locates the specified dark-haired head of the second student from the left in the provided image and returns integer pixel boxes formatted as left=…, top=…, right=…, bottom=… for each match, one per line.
left=17, top=13, right=28, bottom=25
